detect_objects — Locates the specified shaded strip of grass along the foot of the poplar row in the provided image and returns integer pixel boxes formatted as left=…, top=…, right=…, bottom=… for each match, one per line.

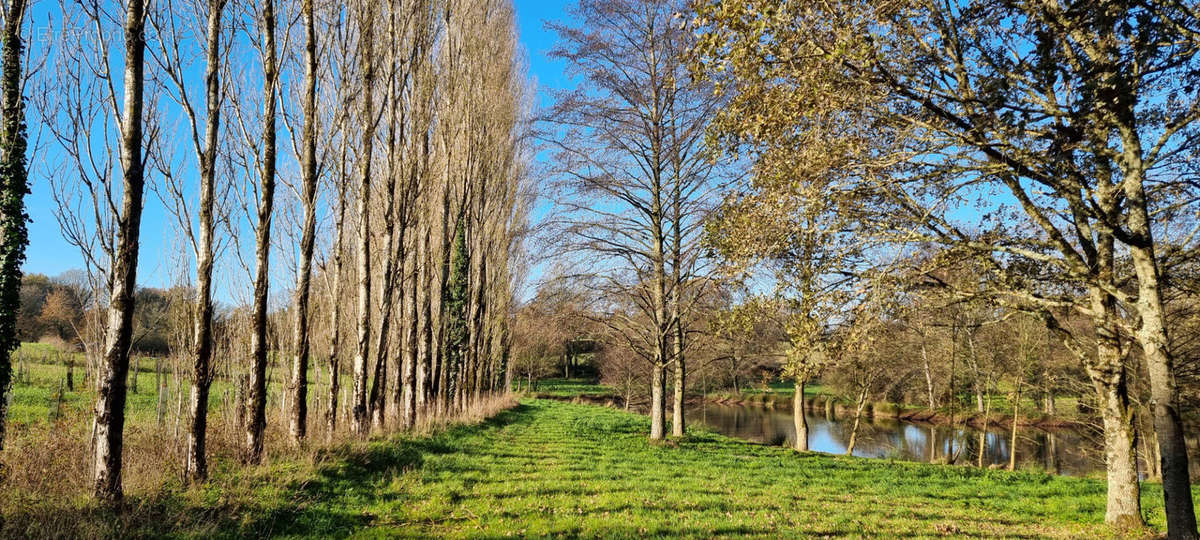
left=0, top=404, right=538, bottom=538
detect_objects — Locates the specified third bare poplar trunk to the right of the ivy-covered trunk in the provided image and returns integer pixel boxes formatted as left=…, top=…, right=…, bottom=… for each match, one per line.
left=246, top=0, right=278, bottom=463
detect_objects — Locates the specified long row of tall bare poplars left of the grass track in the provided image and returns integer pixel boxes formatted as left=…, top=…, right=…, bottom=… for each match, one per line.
left=0, top=0, right=528, bottom=500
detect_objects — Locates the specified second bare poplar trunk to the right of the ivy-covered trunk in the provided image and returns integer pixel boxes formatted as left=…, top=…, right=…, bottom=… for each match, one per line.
left=184, top=0, right=226, bottom=484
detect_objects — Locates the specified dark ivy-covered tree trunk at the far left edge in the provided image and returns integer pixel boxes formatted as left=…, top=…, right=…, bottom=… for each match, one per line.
left=0, top=0, right=29, bottom=458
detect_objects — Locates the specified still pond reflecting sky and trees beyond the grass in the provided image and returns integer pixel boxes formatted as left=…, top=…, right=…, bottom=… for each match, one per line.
left=686, top=403, right=1104, bottom=476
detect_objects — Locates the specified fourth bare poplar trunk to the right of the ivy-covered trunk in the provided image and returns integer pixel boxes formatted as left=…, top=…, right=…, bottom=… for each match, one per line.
left=290, top=0, right=318, bottom=444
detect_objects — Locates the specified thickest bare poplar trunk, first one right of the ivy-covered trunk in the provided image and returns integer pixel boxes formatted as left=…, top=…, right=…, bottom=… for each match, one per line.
left=92, top=0, right=145, bottom=502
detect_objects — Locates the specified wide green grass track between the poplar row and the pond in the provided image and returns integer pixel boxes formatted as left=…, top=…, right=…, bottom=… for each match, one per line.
left=0, top=400, right=1190, bottom=538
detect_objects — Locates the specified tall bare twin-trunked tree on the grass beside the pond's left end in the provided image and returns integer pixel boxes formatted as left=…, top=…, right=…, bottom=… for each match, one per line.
left=542, top=0, right=720, bottom=439
